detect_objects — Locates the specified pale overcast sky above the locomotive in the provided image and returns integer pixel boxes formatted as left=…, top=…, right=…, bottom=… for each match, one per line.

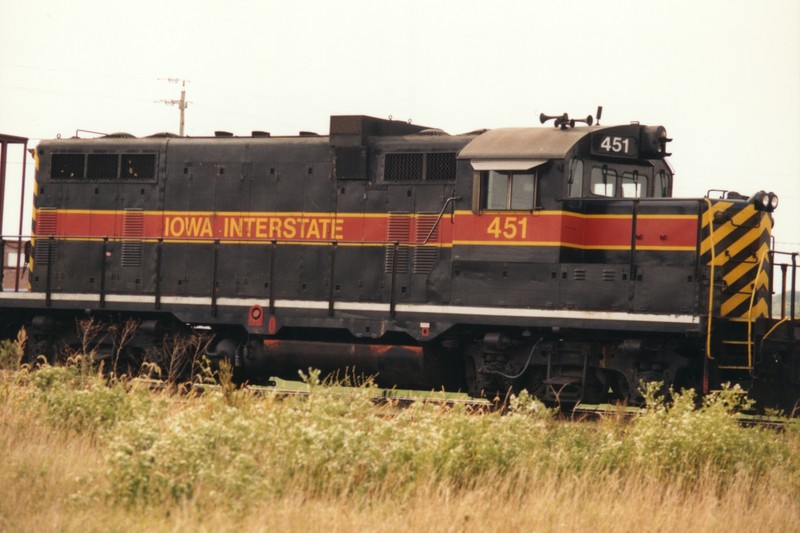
left=0, top=0, right=800, bottom=250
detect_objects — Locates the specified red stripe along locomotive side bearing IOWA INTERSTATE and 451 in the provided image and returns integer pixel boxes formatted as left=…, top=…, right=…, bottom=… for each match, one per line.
left=40, top=211, right=698, bottom=249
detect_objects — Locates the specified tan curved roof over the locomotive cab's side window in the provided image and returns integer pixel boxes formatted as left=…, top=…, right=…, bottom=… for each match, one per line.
left=458, top=127, right=597, bottom=164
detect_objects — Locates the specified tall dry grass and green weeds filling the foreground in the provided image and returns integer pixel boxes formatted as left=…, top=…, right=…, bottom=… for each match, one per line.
left=0, top=352, right=800, bottom=531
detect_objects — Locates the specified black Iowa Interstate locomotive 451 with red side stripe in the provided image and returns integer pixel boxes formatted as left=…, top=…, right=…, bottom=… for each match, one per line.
left=0, top=114, right=800, bottom=409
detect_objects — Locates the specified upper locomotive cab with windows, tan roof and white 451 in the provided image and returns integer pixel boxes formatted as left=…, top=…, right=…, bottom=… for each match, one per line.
left=459, top=124, right=673, bottom=213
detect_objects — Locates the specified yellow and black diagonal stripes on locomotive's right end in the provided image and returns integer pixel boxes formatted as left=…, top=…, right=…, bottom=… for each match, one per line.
left=700, top=200, right=772, bottom=320
